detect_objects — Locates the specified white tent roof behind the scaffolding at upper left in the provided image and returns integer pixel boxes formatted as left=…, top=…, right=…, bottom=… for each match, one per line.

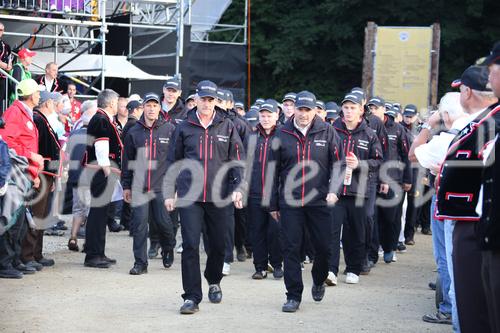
left=30, top=52, right=171, bottom=81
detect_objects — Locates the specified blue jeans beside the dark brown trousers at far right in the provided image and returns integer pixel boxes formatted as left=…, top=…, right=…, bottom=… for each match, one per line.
left=431, top=196, right=451, bottom=314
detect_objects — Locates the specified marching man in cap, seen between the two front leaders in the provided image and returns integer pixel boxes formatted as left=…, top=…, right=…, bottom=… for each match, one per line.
left=247, top=99, right=283, bottom=280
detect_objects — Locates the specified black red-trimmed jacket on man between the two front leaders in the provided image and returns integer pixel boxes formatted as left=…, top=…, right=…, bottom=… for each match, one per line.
left=245, top=124, right=278, bottom=199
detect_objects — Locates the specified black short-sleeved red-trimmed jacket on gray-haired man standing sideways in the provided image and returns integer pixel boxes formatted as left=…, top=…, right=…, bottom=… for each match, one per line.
left=83, top=109, right=123, bottom=171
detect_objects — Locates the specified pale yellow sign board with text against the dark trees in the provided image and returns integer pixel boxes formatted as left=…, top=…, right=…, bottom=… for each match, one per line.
left=373, top=27, right=432, bottom=112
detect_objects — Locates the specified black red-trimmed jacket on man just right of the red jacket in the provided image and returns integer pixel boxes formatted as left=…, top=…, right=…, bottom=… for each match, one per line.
left=33, top=110, right=62, bottom=177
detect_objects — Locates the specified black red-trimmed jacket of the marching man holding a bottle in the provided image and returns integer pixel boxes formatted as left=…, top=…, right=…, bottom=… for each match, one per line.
left=333, top=118, right=384, bottom=198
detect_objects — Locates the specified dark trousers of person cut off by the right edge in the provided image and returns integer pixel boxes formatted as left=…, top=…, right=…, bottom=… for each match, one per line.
left=481, top=250, right=500, bottom=333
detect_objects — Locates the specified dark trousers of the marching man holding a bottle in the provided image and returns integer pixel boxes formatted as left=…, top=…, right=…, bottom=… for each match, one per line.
left=333, top=196, right=367, bottom=275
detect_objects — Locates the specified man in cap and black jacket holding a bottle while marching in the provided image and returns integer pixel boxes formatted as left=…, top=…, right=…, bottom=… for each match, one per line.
left=330, top=93, right=383, bottom=284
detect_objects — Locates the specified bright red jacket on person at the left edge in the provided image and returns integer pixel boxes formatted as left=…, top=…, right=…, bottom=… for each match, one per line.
left=0, top=100, right=38, bottom=179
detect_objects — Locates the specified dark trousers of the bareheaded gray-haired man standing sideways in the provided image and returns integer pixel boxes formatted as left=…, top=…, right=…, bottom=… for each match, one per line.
left=85, top=170, right=117, bottom=260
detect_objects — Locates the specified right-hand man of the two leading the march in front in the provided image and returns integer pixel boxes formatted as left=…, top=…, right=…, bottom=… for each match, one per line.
left=270, top=91, right=343, bottom=312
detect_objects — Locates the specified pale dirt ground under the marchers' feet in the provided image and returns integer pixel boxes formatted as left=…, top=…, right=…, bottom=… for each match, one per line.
left=0, top=218, right=452, bottom=332
